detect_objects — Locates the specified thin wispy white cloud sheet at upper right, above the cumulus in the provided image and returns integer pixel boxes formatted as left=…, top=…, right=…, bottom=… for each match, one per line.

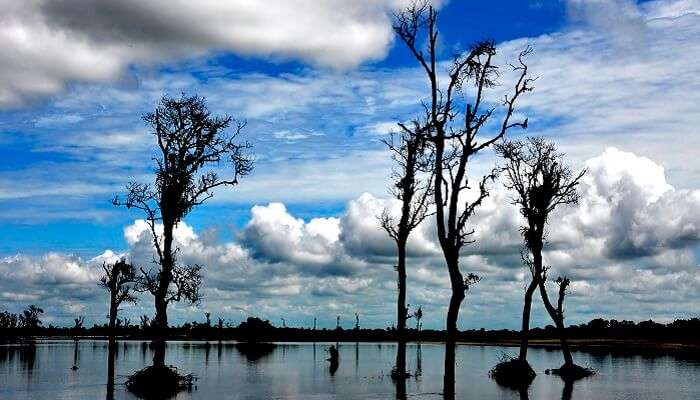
left=500, top=0, right=700, bottom=187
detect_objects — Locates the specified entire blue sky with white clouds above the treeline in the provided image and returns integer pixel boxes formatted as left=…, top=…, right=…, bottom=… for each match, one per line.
left=0, top=0, right=700, bottom=329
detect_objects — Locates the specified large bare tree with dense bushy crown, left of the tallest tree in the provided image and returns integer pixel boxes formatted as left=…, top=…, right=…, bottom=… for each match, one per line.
left=113, top=95, right=253, bottom=365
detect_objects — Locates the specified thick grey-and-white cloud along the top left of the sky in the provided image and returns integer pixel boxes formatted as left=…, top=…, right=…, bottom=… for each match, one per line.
left=0, top=0, right=438, bottom=106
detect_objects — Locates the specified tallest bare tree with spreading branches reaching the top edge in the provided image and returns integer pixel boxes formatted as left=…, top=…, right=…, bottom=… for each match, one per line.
left=394, top=1, right=532, bottom=397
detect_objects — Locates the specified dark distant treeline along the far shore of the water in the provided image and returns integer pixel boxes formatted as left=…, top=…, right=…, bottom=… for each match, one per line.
left=0, top=306, right=700, bottom=344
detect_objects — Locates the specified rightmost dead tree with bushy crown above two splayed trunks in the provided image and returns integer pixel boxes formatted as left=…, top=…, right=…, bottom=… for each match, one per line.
left=497, top=137, right=585, bottom=376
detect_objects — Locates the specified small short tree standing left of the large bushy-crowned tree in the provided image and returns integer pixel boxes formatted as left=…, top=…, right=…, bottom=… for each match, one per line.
left=99, top=258, right=136, bottom=340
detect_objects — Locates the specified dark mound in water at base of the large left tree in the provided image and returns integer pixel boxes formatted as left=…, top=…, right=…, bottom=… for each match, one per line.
left=125, top=365, right=197, bottom=399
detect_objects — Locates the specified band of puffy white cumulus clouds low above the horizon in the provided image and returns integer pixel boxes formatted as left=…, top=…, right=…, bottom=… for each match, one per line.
left=0, top=148, right=700, bottom=328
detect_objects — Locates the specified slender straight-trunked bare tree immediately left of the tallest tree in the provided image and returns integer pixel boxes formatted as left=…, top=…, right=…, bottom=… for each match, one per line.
left=381, top=121, right=432, bottom=378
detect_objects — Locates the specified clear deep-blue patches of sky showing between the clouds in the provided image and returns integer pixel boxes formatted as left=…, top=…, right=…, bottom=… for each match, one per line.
left=0, top=1, right=567, bottom=256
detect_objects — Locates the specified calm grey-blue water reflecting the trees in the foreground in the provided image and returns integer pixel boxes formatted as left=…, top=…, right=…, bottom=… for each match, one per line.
left=0, top=341, right=700, bottom=400
